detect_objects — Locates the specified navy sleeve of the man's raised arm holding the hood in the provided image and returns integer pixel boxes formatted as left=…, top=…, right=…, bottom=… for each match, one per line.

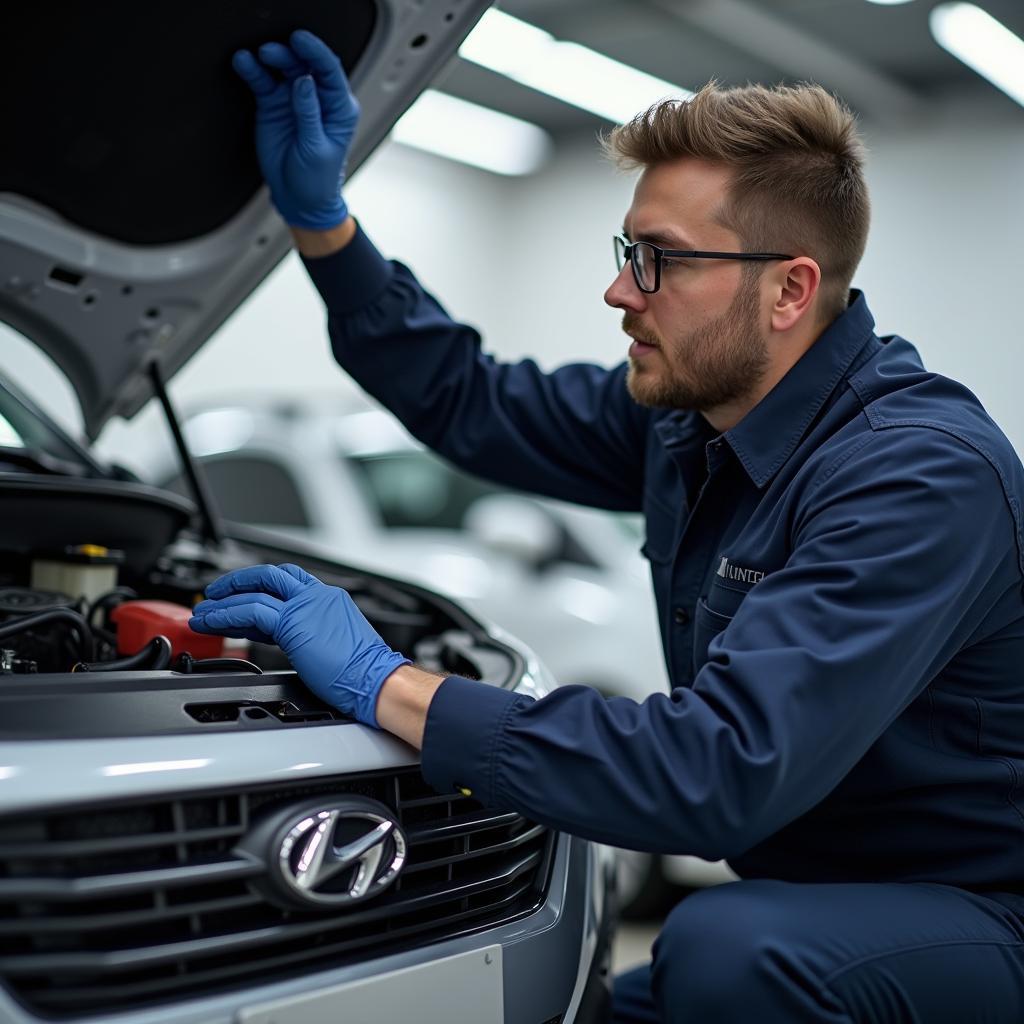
left=304, top=230, right=648, bottom=511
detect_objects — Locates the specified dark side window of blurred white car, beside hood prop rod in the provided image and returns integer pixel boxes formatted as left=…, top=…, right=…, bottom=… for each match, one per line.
left=164, top=456, right=310, bottom=526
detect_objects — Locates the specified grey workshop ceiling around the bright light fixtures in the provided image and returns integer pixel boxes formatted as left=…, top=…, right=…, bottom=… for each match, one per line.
left=438, top=0, right=1024, bottom=137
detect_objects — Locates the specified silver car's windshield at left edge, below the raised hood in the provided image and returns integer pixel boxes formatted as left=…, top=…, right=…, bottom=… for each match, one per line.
left=0, top=378, right=105, bottom=476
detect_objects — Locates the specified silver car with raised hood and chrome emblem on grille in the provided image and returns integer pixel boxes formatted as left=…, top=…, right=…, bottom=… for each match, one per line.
left=0, top=0, right=613, bottom=1024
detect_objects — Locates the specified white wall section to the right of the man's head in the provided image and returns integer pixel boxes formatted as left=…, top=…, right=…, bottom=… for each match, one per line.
left=856, top=110, right=1024, bottom=444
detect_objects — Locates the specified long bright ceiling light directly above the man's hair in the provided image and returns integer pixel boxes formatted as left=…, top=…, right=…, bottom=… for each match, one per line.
left=459, top=8, right=693, bottom=124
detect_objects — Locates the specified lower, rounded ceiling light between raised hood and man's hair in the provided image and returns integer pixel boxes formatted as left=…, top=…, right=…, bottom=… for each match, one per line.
left=391, top=89, right=552, bottom=175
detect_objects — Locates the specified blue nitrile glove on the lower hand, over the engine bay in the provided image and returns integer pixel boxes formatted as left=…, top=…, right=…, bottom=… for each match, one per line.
left=188, top=565, right=411, bottom=729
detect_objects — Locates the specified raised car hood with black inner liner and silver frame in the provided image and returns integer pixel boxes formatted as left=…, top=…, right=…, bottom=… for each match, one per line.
left=0, top=0, right=489, bottom=438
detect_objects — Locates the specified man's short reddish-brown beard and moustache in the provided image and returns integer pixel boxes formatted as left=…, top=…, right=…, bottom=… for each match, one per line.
left=623, top=275, right=768, bottom=413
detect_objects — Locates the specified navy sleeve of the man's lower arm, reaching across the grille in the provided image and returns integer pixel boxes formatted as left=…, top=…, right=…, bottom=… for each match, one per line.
left=423, top=428, right=1021, bottom=859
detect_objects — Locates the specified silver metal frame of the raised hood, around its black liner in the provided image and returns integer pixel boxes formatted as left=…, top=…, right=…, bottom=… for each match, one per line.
left=0, top=0, right=490, bottom=438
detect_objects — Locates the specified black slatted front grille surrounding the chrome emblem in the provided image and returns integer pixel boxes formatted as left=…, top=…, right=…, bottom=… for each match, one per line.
left=0, top=768, right=557, bottom=1019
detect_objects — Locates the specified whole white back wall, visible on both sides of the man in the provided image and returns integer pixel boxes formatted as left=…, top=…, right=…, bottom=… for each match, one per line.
left=6, top=96, right=1024, bottom=464
